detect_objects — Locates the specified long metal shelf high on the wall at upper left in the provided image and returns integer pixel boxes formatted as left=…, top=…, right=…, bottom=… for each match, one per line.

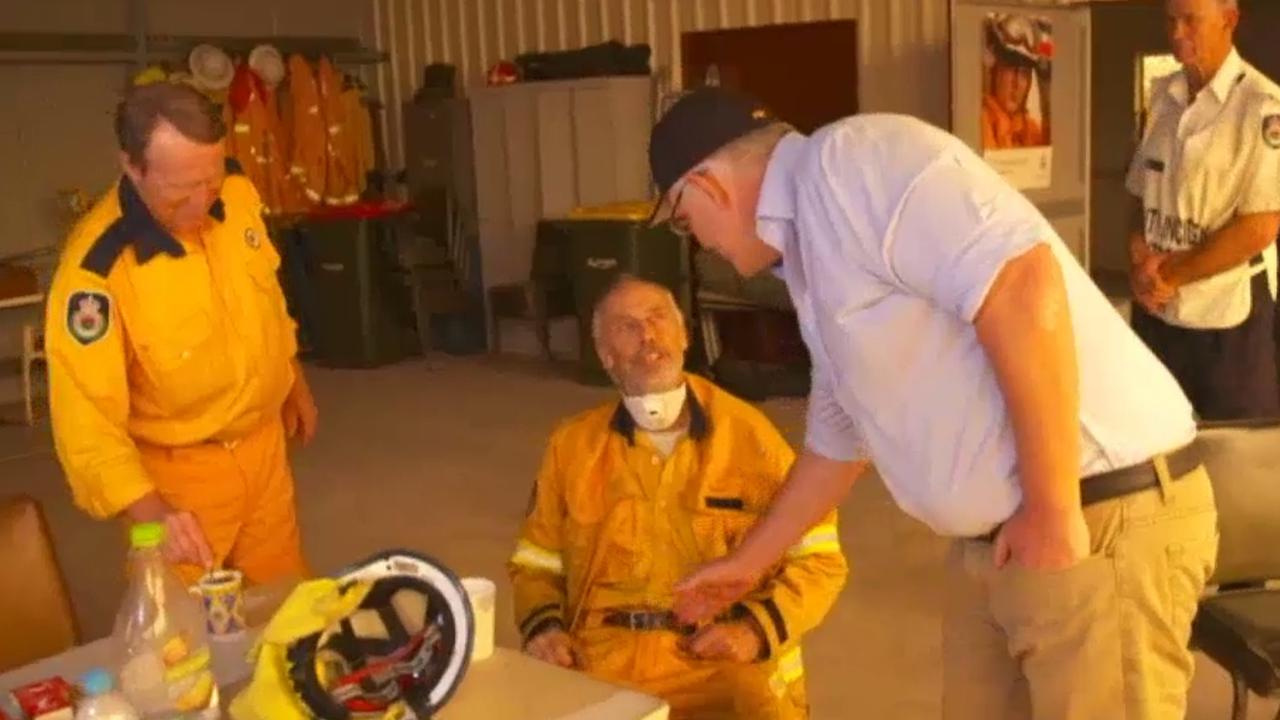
left=0, top=32, right=389, bottom=65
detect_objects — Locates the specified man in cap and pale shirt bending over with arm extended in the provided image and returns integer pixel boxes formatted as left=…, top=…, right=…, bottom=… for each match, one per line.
left=649, top=88, right=1217, bottom=720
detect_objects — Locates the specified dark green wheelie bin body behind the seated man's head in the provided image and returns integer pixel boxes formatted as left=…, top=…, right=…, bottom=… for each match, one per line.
left=547, top=218, right=694, bottom=384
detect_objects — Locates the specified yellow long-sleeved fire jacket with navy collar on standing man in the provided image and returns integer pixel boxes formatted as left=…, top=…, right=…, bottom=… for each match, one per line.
left=45, top=163, right=297, bottom=518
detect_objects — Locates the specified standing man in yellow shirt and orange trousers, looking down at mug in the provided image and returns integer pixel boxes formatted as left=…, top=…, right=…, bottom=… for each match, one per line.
left=45, top=83, right=316, bottom=583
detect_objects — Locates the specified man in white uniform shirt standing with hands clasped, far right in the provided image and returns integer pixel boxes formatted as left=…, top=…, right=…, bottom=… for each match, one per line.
left=1126, top=0, right=1280, bottom=420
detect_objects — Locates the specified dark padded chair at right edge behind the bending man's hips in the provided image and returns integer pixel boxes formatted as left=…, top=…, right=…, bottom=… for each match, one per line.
left=1192, top=419, right=1280, bottom=720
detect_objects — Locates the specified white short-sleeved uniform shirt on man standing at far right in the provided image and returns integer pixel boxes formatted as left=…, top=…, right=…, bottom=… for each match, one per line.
left=1125, top=50, right=1280, bottom=328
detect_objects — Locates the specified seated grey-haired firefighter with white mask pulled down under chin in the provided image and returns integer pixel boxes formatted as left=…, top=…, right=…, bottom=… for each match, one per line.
left=508, top=278, right=847, bottom=719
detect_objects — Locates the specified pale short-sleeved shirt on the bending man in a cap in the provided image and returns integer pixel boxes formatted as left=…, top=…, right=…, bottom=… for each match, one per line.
left=756, top=114, right=1196, bottom=537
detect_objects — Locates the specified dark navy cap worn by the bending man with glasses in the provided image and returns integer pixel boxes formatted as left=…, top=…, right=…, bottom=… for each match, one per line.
left=649, top=87, right=774, bottom=215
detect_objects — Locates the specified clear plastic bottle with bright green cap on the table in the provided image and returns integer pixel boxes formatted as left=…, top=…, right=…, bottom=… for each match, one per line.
left=113, top=523, right=219, bottom=719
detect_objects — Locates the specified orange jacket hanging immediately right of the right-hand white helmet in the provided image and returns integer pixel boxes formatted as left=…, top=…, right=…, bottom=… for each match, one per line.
left=285, top=55, right=329, bottom=206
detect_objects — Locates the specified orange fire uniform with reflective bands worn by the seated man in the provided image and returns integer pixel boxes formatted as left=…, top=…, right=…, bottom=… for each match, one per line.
left=508, top=377, right=847, bottom=719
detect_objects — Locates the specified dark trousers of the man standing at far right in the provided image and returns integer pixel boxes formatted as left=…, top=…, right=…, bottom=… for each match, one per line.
left=1133, top=272, right=1280, bottom=420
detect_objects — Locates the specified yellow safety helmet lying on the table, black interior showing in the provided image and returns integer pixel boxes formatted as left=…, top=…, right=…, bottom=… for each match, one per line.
left=230, top=551, right=475, bottom=720
